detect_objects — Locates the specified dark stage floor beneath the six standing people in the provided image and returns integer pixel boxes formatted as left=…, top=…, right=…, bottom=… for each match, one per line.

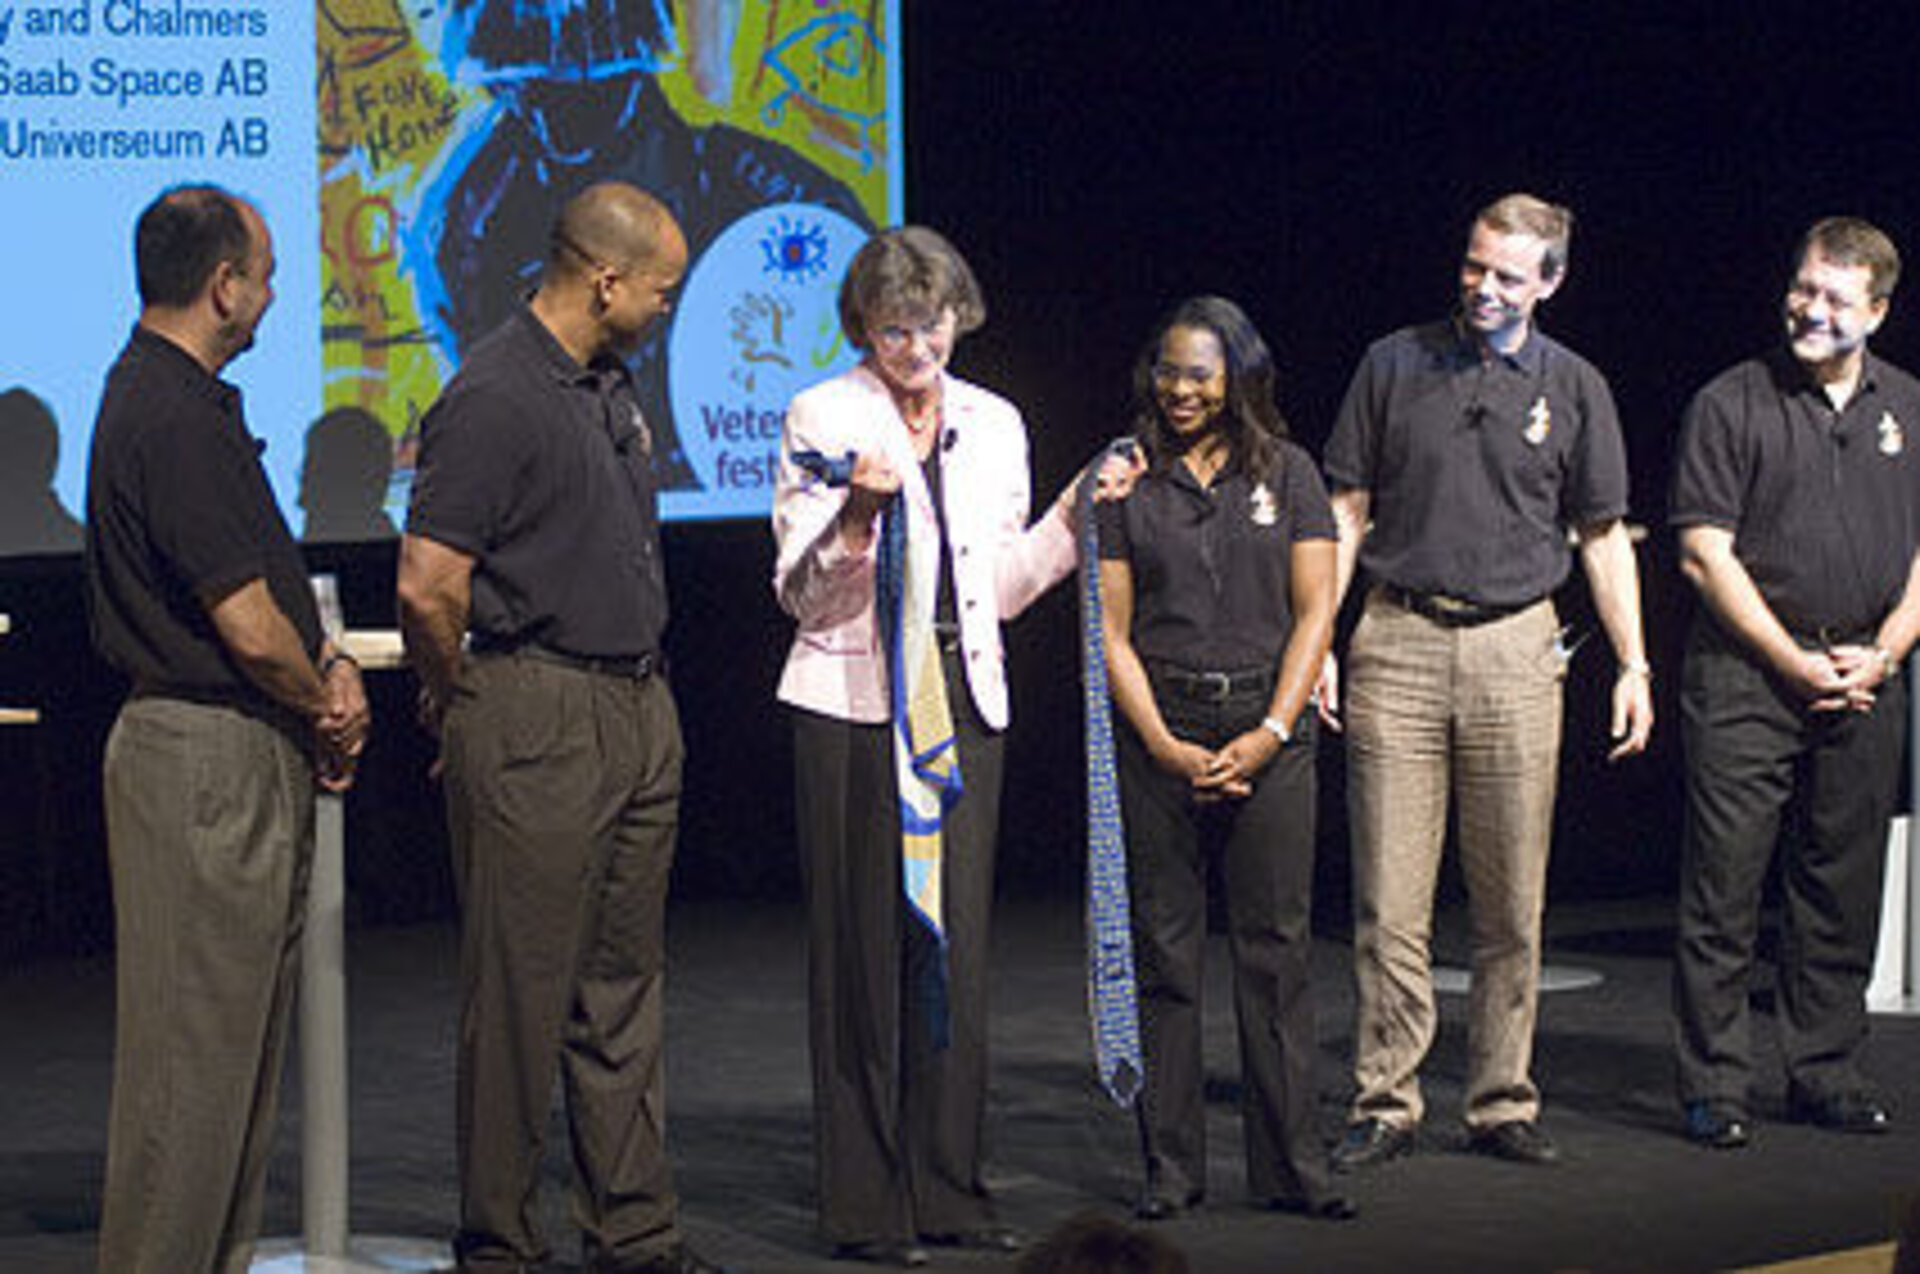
left=0, top=900, right=1920, bottom=1274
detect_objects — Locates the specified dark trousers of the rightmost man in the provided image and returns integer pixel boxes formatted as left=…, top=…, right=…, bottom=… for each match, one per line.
left=1674, top=620, right=1907, bottom=1105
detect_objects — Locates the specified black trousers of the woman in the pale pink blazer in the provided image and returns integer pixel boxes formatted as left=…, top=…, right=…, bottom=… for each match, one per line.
left=793, top=658, right=1004, bottom=1243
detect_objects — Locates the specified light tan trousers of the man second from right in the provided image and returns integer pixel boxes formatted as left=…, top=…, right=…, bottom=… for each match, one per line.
left=1348, top=591, right=1565, bottom=1128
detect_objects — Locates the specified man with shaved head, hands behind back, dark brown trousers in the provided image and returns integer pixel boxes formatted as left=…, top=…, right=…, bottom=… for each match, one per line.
left=399, top=182, right=714, bottom=1274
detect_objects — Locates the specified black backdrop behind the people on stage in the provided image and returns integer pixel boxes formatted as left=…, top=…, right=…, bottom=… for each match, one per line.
left=0, top=0, right=1920, bottom=957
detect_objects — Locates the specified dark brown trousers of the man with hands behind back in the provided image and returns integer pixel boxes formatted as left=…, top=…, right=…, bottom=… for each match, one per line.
left=445, top=654, right=684, bottom=1272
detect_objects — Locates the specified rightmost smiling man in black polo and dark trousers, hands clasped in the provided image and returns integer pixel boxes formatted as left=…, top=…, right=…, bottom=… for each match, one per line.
left=1670, top=217, right=1920, bottom=1149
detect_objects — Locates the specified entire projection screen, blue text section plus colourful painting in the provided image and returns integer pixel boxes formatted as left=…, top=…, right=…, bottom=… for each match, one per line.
left=0, top=0, right=900, bottom=554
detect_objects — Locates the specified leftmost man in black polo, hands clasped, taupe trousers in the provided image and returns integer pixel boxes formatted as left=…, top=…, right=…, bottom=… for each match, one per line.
left=86, top=186, right=367, bottom=1274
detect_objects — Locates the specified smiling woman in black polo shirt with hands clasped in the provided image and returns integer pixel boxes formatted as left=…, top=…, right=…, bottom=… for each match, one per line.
left=1100, top=297, right=1354, bottom=1220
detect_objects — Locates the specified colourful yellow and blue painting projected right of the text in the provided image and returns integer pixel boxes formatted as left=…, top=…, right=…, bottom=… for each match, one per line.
left=319, top=0, right=899, bottom=518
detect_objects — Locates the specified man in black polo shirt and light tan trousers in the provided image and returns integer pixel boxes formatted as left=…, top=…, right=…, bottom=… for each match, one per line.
left=1323, top=194, right=1653, bottom=1170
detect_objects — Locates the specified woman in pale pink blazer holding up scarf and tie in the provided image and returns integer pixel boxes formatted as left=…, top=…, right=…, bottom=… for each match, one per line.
left=774, top=226, right=1121, bottom=1264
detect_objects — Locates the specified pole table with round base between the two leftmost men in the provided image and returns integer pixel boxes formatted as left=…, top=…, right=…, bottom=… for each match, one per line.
left=253, top=631, right=453, bottom=1274
